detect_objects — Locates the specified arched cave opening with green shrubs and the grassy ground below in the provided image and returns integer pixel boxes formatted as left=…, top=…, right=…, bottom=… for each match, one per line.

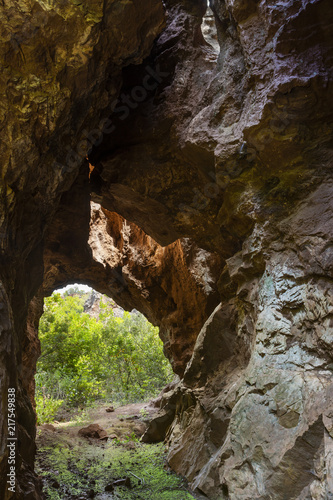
left=36, top=284, right=194, bottom=500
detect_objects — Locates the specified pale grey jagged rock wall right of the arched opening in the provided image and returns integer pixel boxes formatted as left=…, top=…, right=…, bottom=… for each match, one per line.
left=164, top=183, right=333, bottom=499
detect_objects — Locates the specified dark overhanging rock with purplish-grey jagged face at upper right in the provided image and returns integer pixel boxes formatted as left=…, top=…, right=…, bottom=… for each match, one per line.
left=90, top=2, right=332, bottom=258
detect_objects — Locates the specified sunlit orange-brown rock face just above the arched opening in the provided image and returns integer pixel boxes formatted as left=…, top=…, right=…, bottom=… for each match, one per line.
left=89, top=206, right=220, bottom=376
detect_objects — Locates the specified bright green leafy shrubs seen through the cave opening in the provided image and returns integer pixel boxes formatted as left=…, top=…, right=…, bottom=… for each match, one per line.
left=35, top=293, right=173, bottom=424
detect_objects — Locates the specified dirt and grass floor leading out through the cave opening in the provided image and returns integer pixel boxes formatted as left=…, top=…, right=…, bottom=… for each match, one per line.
left=36, top=403, right=195, bottom=500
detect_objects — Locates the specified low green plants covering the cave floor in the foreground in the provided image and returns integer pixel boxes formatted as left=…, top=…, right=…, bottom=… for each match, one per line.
left=36, top=433, right=194, bottom=500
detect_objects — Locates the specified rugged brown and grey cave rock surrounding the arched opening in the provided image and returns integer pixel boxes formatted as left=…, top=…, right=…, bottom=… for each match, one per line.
left=0, top=0, right=333, bottom=500
